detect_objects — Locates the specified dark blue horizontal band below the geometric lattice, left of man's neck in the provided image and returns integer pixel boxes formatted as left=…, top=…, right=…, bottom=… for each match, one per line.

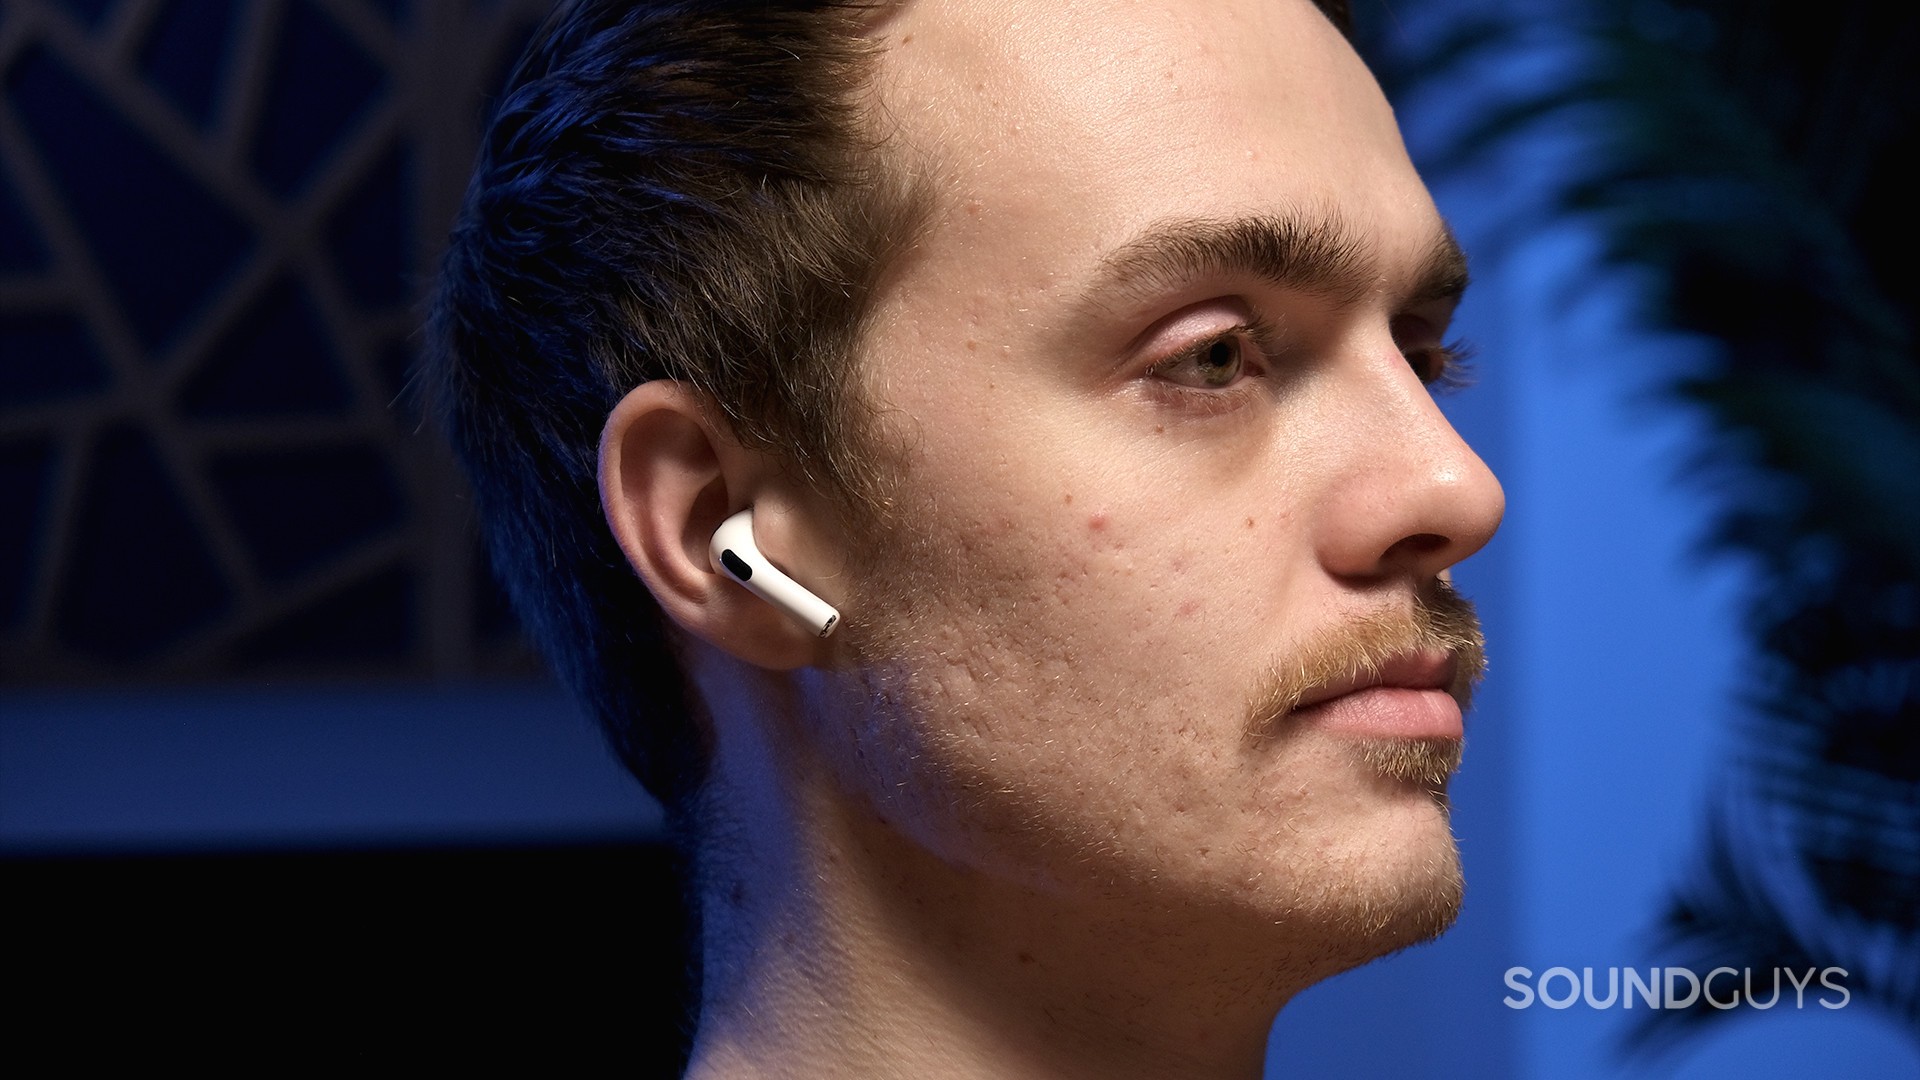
left=0, top=682, right=660, bottom=855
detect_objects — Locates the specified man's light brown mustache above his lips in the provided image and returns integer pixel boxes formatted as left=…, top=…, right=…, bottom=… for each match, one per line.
left=1246, top=580, right=1486, bottom=738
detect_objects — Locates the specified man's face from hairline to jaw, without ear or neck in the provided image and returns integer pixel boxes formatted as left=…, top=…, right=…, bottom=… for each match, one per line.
left=802, top=0, right=1501, bottom=957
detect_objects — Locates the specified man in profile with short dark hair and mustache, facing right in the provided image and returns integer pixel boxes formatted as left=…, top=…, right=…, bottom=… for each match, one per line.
left=436, top=0, right=1501, bottom=1080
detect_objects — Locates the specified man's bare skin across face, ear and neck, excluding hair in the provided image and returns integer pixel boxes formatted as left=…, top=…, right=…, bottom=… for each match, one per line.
left=603, top=0, right=1503, bottom=1080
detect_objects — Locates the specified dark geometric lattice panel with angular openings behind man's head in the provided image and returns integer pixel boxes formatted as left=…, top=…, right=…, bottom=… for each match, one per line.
left=0, top=0, right=553, bottom=684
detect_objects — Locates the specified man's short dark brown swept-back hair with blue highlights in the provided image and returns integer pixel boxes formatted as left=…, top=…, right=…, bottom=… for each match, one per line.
left=424, top=0, right=1346, bottom=826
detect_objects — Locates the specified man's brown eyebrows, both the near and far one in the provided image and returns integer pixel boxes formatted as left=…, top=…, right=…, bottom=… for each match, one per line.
left=1081, top=215, right=1467, bottom=309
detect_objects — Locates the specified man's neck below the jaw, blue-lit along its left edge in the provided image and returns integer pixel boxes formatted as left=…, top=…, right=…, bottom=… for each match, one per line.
left=687, top=757, right=1320, bottom=1080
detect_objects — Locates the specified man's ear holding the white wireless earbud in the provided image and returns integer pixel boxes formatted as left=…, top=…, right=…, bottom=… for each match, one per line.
left=599, top=379, right=824, bottom=671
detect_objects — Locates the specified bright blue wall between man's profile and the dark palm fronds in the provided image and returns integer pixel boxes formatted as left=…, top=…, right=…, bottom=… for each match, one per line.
left=1269, top=148, right=1920, bottom=1080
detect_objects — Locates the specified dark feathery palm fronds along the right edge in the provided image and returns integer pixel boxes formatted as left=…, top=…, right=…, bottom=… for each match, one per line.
left=1371, top=0, right=1920, bottom=1049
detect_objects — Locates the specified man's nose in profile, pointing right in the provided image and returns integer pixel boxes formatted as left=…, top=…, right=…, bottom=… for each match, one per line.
left=1317, top=353, right=1507, bottom=580
